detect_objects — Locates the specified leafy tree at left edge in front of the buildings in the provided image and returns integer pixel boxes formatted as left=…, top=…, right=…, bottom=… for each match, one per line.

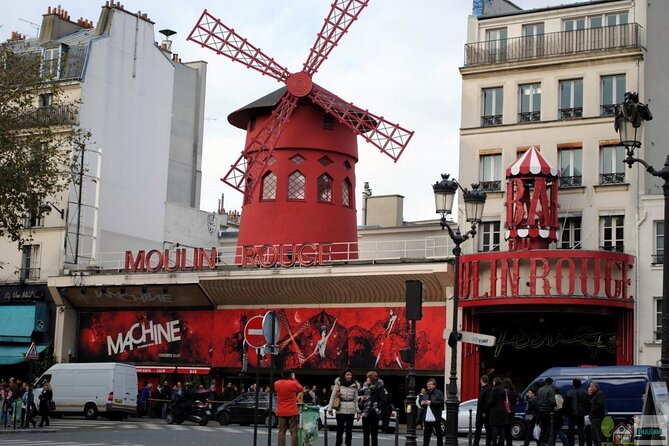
left=0, top=41, right=90, bottom=249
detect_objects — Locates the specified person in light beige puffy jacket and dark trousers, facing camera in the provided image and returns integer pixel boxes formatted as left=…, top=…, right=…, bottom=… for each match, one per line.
left=327, top=369, right=360, bottom=446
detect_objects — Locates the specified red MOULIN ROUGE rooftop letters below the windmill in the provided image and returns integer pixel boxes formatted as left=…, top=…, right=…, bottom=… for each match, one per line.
left=125, top=243, right=331, bottom=273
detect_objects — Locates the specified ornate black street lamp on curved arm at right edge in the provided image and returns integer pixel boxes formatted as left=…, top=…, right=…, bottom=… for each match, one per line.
left=614, top=93, right=669, bottom=385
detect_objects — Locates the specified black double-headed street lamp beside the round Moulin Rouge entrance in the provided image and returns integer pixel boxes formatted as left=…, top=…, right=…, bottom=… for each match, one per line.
left=432, top=174, right=486, bottom=446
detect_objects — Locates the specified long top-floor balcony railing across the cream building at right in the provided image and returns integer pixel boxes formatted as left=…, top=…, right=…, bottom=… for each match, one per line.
left=465, top=23, right=641, bottom=67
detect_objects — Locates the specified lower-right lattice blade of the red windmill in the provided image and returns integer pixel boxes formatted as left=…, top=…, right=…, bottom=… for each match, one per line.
left=310, top=88, right=414, bottom=161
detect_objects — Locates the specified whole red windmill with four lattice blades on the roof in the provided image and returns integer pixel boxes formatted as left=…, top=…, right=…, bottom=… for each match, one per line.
left=188, top=0, right=413, bottom=265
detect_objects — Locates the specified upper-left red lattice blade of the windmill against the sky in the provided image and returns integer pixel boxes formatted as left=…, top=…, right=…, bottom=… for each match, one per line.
left=188, top=9, right=288, bottom=82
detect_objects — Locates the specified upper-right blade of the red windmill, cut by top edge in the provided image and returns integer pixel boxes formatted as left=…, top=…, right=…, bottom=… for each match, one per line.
left=304, top=0, right=369, bottom=75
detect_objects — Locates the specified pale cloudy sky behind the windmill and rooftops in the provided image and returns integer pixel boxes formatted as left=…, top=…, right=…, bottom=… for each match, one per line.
left=0, top=0, right=573, bottom=223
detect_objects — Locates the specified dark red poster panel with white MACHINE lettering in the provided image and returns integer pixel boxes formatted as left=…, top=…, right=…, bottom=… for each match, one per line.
left=78, top=310, right=213, bottom=365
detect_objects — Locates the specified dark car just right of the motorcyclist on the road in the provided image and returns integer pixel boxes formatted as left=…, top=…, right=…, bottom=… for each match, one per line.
left=215, top=392, right=278, bottom=427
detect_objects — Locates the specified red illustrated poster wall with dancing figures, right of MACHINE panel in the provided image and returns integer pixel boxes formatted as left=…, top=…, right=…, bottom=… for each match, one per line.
left=213, top=305, right=446, bottom=370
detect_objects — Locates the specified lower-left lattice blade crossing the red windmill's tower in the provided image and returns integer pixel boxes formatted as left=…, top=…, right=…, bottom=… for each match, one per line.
left=221, top=93, right=298, bottom=202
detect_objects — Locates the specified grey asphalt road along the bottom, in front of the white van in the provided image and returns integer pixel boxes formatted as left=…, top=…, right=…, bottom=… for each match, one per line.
left=0, top=417, right=414, bottom=446
